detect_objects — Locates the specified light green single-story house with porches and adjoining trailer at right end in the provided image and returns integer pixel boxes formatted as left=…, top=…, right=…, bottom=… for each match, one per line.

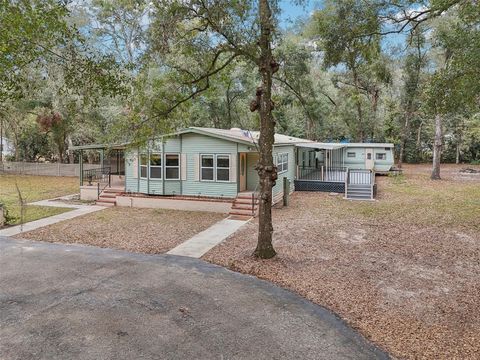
left=72, top=127, right=393, bottom=214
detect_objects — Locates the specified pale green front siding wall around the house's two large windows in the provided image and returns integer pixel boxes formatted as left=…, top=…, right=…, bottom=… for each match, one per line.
left=125, top=133, right=239, bottom=198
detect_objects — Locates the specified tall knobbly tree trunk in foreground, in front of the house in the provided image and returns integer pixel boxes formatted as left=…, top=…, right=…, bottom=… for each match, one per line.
left=254, top=0, right=278, bottom=259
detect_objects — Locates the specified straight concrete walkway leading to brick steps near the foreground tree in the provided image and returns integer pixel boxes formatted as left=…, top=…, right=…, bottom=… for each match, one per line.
left=167, top=218, right=250, bottom=258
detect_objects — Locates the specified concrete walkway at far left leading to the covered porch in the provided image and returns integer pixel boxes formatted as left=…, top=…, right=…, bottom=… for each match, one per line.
left=0, top=195, right=105, bottom=236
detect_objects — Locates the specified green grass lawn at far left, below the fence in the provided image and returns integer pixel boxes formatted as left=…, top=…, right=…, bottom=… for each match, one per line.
left=0, top=174, right=78, bottom=224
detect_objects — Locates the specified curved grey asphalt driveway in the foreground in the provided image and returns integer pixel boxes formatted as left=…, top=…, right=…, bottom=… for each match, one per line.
left=0, top=237, right=386, bottom=360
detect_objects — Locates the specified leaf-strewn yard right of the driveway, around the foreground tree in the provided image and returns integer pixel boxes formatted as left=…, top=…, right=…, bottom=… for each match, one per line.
left=204, top=165, right=480, bottom=359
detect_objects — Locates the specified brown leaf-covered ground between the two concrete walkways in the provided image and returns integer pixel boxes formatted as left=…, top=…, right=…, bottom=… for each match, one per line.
left=16, top=207, right=226, bottom=254
